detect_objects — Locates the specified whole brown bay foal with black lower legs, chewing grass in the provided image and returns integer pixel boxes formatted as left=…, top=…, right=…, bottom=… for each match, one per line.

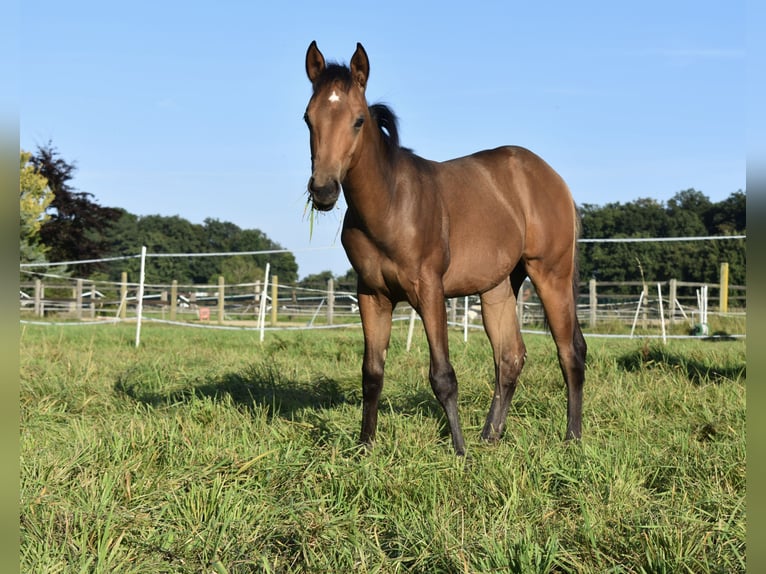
left=304, top=42, right=586, bottom=455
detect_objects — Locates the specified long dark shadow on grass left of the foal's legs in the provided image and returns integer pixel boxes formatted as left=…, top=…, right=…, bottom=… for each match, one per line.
left=114, top=369, right=355, bottom=419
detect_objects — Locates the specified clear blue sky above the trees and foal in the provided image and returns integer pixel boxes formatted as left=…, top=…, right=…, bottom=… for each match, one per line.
left=18, top=0, right=747, bottom=276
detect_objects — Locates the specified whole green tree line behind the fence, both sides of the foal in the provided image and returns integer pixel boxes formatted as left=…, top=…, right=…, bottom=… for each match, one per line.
left=19, top=143, right=746, bottom=290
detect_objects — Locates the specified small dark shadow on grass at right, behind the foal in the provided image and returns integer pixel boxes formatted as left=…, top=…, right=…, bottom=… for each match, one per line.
left=617, top=345, right=747, bottom=385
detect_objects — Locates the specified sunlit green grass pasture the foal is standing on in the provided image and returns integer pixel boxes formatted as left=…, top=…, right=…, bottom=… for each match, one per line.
left=20, top=325, right=746, bottom=574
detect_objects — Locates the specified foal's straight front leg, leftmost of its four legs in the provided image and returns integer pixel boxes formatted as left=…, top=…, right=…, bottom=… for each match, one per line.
left=359, top=293, right=393, bottom=447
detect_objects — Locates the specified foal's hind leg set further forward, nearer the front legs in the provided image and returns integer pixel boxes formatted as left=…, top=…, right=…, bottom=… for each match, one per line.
left=481, top=279, right=526, bottom=442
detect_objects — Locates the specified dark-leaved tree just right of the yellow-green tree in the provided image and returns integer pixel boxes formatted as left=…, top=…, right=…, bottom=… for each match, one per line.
left=31, top=143, right=120, bottom=276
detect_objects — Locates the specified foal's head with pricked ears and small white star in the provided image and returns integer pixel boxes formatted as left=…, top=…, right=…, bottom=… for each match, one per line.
left=304, top=42, right=370, bottom=211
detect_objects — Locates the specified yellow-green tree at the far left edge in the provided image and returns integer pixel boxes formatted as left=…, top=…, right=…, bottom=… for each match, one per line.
left=19, top=151, right=53, bottom=263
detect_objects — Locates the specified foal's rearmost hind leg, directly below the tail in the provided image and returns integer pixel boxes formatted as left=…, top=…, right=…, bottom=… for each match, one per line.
left=529, top=266, right=588, bottom=440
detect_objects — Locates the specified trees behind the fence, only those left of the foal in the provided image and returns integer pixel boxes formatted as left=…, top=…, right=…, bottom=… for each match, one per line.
left=20, top=144, right=298, bottom=283
